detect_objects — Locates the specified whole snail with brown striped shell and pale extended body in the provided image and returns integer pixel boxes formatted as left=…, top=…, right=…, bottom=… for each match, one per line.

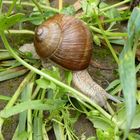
left=21, top=15, right=120, bottom=108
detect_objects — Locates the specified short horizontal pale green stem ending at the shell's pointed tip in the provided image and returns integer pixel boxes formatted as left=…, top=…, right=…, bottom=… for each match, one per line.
left=4, top=30, right=35, bottom=35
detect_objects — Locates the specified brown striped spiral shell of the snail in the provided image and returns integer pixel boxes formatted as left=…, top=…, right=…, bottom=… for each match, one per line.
left=34, top=15, right=92, bottom=70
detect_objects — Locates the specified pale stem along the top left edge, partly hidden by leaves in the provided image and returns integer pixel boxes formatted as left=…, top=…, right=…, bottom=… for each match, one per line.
left=3, top=0, right=59, bottom=13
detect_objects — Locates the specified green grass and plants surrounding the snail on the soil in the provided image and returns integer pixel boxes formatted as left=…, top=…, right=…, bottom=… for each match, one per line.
left=0, top=0, right=140, bottom=140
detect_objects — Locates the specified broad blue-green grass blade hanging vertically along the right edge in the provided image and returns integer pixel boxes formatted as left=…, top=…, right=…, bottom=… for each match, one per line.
left=119, top=8, right=140, bottom=137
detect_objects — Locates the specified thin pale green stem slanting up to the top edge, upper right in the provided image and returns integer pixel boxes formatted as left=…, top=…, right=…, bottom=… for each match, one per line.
left=100, top=0, right=131, bottom=12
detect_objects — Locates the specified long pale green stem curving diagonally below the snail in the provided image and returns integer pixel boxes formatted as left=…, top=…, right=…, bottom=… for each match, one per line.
left=1, top=33, right=117, bottom=125
